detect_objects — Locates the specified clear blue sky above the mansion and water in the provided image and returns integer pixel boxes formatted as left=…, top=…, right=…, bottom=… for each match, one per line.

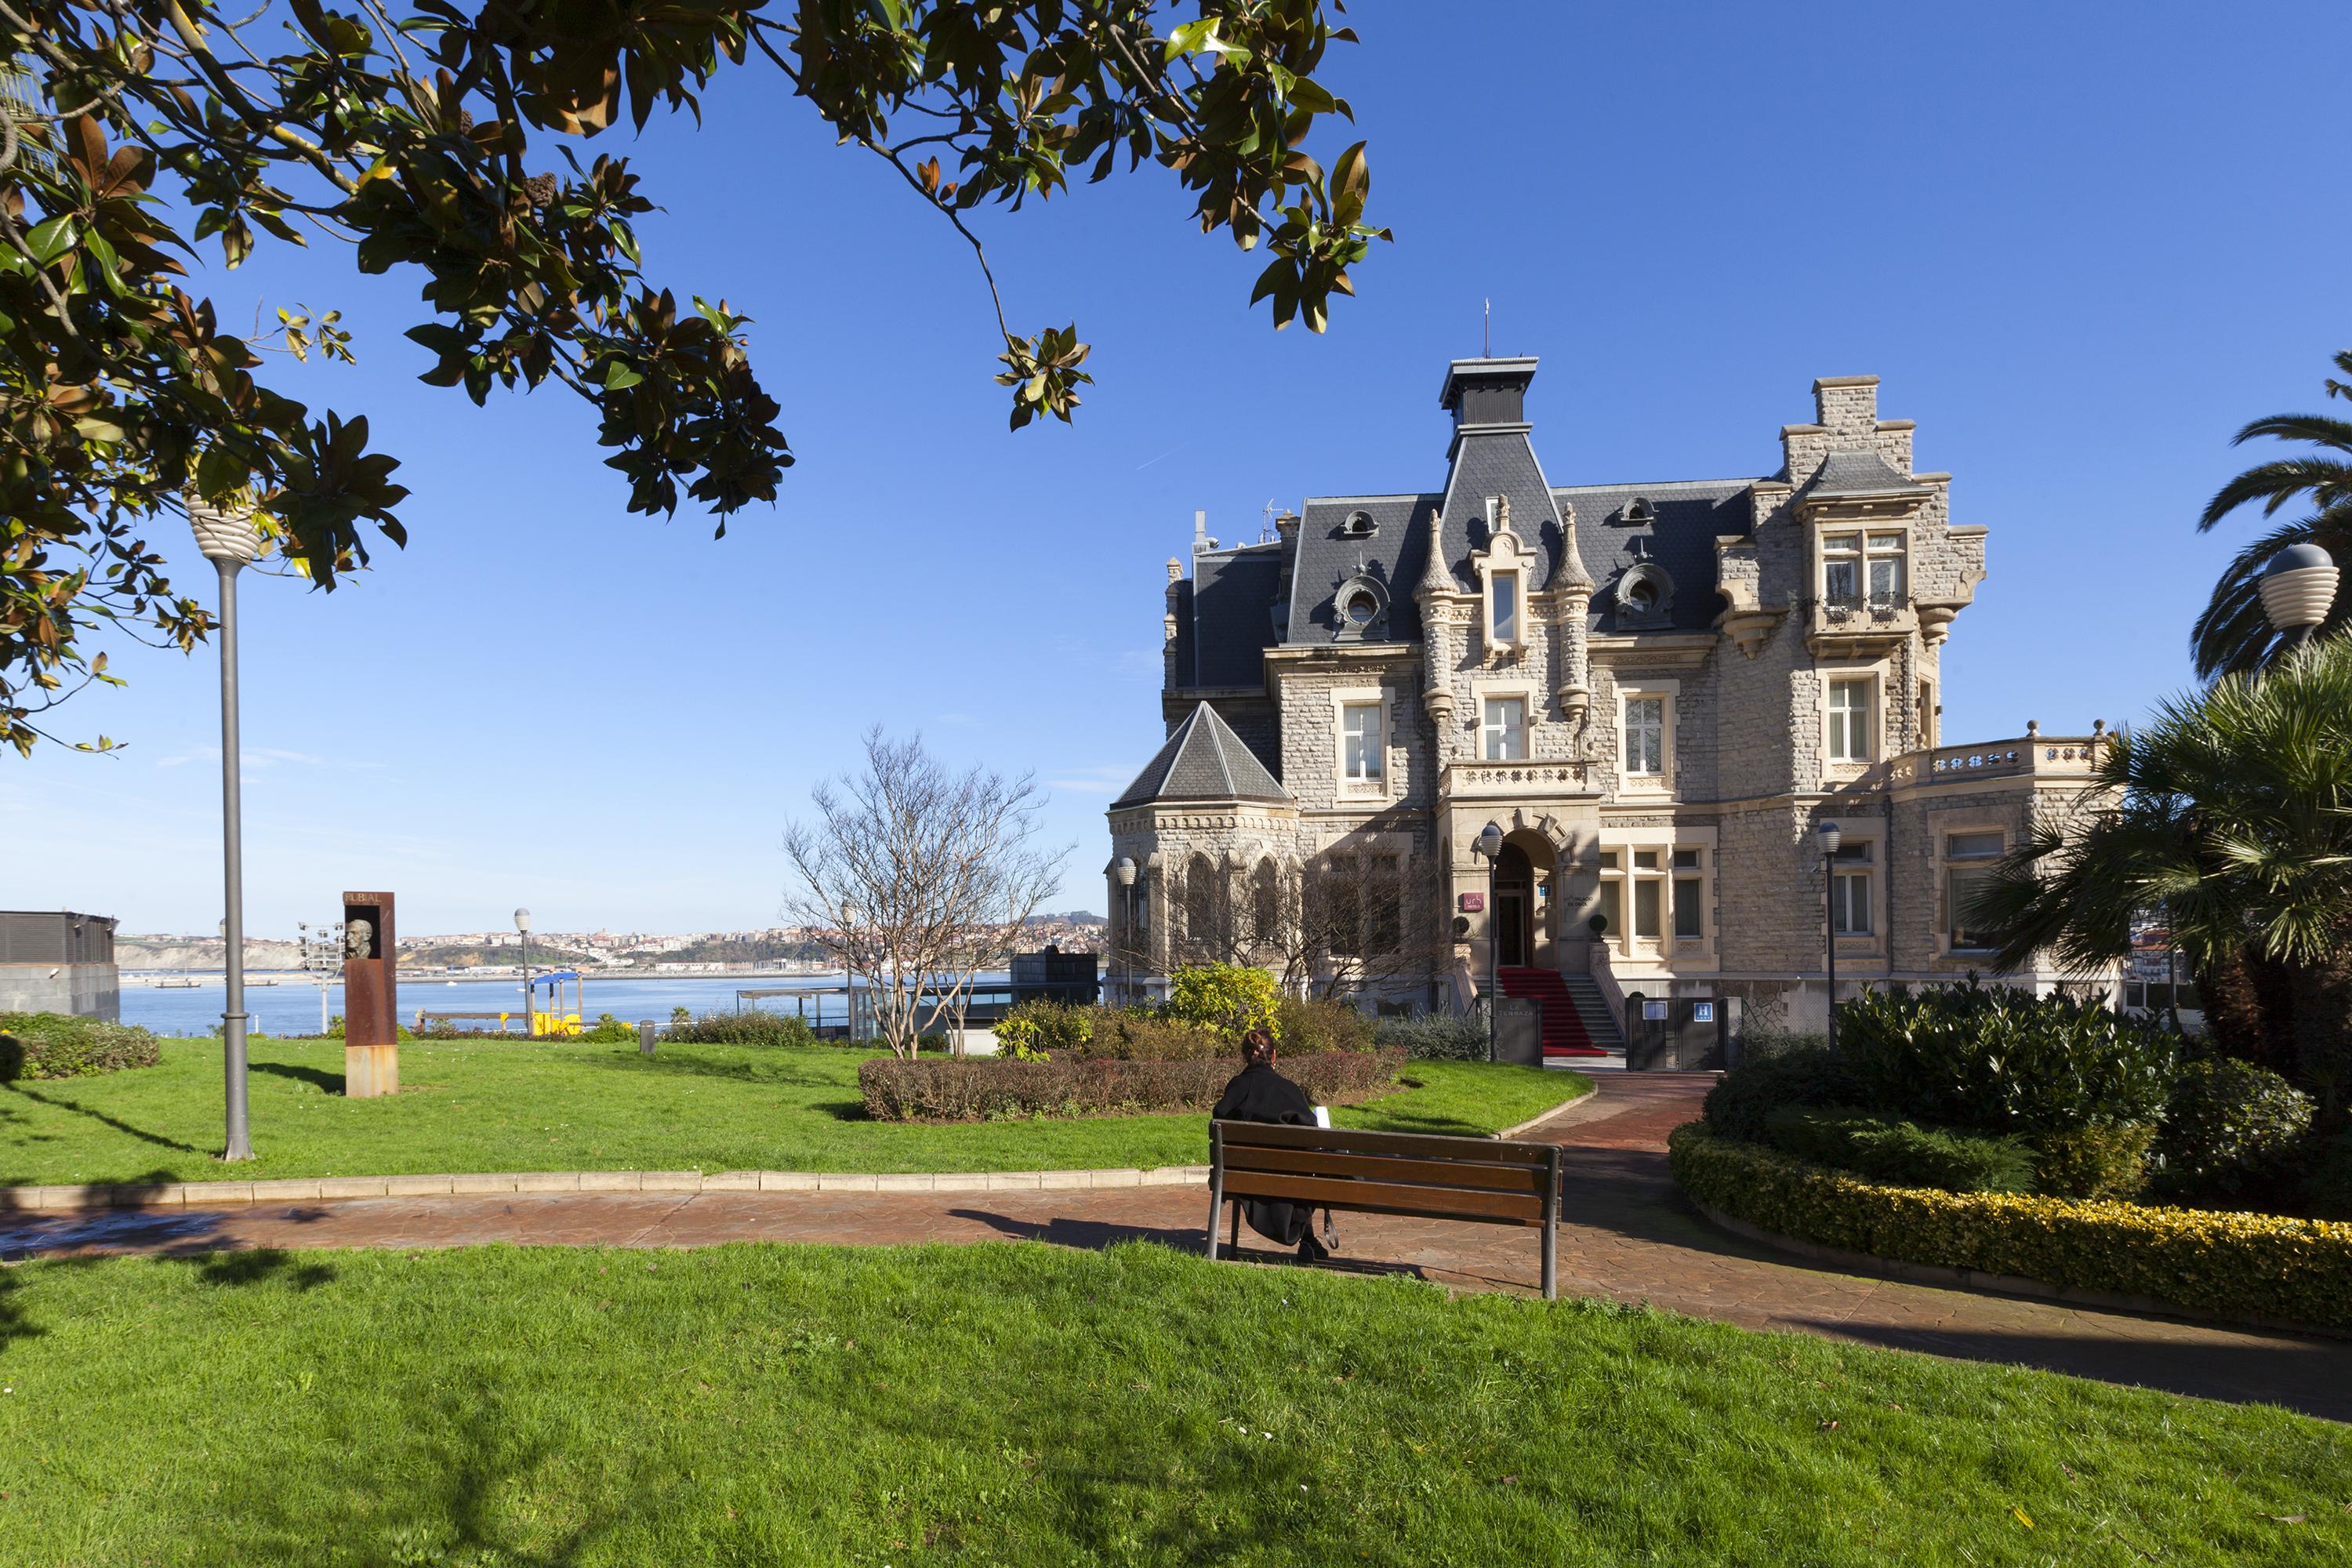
left=0, top=0, right=2352, bottom=933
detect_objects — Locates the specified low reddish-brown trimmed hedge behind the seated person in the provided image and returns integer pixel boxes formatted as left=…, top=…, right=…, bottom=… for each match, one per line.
left=858, top=1051, right=1404, bottom=1121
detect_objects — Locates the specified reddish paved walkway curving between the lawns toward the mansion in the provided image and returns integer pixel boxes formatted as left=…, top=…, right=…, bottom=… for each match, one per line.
left=0, top=1072, right=2352, bottom=1420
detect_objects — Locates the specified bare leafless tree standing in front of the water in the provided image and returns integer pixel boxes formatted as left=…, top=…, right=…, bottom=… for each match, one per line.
left=783, top=724, right=1070, bottom=1058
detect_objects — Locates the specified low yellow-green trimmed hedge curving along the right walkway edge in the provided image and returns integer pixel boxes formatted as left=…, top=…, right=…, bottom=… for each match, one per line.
left=1668, top=1121, right=2352, bottom=1328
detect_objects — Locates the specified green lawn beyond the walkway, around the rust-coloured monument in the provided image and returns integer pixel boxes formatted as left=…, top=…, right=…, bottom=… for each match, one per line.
left=0, top=1039, right=1590, bottom=1185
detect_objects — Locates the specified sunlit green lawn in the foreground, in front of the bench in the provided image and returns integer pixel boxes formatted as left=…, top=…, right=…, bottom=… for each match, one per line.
left=0, top=1243, right=2352, bottom=1568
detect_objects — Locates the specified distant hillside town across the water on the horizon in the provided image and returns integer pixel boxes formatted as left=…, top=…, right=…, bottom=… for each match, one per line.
left=115, top=909, right=1105, bottom=975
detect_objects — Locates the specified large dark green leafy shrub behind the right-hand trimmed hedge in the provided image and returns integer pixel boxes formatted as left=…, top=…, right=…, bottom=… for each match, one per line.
left=1837, top=975, right=2180, bottom=1135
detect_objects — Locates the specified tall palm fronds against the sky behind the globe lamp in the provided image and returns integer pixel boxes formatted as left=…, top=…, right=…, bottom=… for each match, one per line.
left=2190, top=350, right=2352, bottom=677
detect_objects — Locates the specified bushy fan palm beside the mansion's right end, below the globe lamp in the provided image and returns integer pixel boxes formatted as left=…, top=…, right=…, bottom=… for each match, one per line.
left=1971, top=635, right=2352, bottom=1126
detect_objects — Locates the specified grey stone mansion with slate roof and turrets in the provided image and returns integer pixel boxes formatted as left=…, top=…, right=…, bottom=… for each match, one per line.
left=1110, top=358, right=2100, bottom=1044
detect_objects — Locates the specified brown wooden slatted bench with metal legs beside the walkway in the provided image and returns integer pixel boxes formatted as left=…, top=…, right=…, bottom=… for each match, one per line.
left=1209, top=1121, right=1559, bottom=1300
